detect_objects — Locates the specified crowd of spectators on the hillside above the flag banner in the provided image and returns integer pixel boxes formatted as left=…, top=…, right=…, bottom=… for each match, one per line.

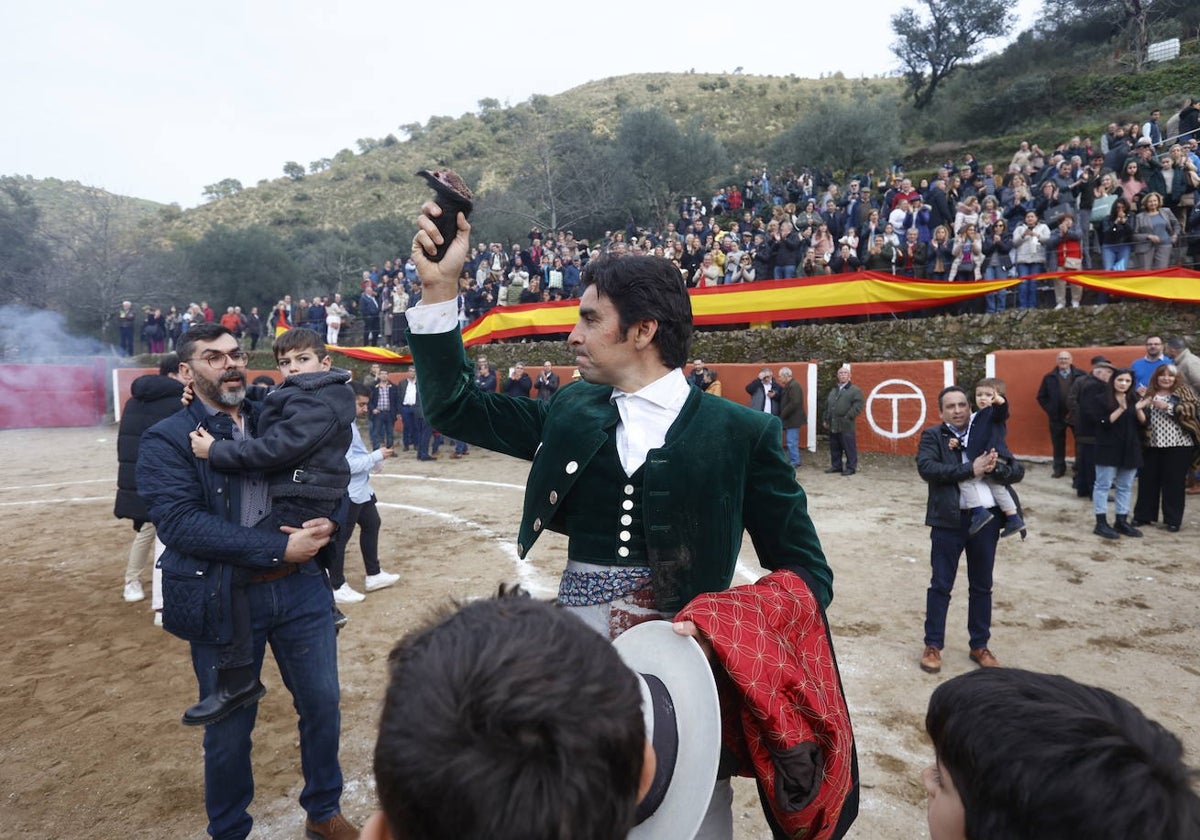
left=119, top=98, right=1200, bottom=354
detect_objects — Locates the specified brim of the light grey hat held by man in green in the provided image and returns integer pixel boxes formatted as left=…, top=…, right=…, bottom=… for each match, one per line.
left=613, top=622, right=721, bottom=840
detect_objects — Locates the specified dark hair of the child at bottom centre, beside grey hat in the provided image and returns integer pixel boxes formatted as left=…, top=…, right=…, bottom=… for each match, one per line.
left=374, top=596, right=646, bottom=840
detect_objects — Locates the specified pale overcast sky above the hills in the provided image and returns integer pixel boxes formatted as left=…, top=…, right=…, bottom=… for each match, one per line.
left=0, top=0, right=1039, bottom=208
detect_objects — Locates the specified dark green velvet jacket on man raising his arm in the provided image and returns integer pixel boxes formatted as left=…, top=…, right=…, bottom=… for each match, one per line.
left=408, top=330, right=833, bottom=612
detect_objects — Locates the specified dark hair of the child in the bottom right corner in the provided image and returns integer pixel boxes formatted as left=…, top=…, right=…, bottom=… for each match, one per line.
left=925, top=668, right=1200, bottom=840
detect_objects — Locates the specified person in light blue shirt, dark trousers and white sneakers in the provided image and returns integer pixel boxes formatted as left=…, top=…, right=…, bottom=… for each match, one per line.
left=329, top=382, right=400, bottom=592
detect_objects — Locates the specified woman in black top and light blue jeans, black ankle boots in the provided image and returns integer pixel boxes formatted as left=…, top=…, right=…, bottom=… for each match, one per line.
left=1082, top=370, right=1151, bottom=540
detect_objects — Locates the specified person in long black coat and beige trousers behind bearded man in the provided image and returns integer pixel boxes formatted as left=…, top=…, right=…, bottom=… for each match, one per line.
left=113, top=353, right=184, bottom=610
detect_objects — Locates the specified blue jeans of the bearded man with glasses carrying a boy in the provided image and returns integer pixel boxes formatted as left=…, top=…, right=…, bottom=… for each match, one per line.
left=192, top=562, right=342, bottom=840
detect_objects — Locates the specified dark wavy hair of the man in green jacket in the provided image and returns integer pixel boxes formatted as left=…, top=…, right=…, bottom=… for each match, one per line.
left=582, top=257, right=692, bottom=367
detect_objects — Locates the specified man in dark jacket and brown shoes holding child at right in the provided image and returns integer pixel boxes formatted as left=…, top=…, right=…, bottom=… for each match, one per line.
left=917, top=385, right=1012, bottom=673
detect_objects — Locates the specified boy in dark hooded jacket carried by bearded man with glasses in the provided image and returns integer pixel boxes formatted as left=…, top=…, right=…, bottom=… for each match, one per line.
left=184, top=328, right=355, bottom=726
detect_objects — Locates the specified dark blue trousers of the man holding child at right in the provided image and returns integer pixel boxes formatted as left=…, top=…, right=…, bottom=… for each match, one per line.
left=925, top=508, right=1004, bottom=650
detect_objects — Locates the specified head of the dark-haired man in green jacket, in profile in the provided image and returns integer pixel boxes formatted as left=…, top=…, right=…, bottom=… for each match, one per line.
left=568, top=257, right=692, bottom=384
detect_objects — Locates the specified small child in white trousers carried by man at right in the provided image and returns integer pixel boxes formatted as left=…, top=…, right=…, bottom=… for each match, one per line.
left=950, top=378, right=1025, bottom=536
